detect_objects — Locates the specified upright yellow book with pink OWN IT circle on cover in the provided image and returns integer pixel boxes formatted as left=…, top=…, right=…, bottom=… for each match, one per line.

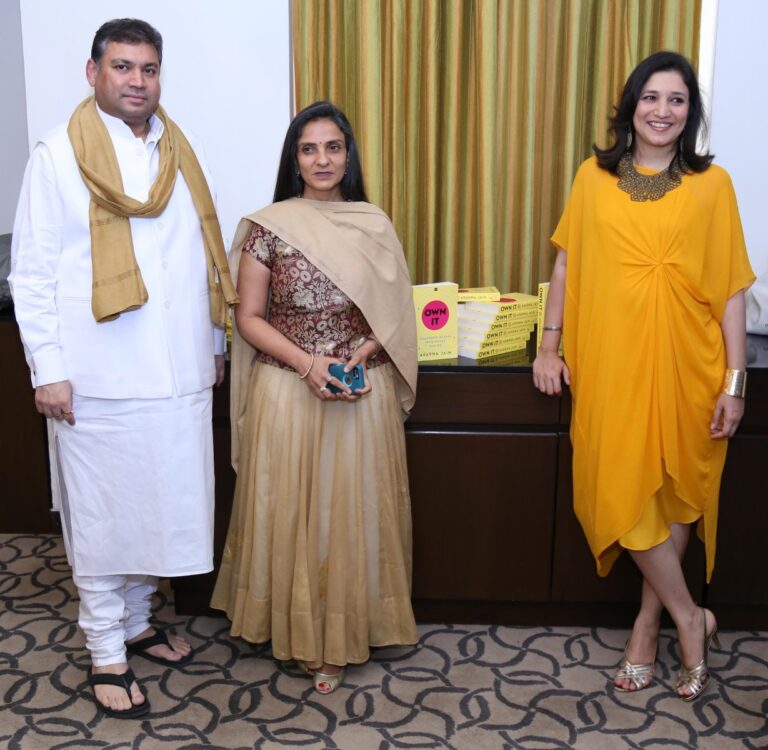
left=413, top=281, right=459, bottom=362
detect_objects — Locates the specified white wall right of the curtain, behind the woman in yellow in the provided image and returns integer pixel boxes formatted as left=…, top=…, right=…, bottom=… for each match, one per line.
left=710, top=0, right=768, bottom=286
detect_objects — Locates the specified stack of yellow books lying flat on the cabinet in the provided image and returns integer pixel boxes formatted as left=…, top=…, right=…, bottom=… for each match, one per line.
left=459, top=292, right=539, bottom=359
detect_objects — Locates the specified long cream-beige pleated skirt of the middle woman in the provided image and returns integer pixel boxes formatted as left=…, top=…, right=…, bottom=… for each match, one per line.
left=211, top=363, right=417, bottom=666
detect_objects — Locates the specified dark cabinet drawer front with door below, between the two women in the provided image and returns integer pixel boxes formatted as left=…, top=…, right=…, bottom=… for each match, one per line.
left=406, top=368, right=559, bottom=604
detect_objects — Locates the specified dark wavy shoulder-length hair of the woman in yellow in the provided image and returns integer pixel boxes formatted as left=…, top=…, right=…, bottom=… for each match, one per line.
left=592, top=50, right=714, bottom=174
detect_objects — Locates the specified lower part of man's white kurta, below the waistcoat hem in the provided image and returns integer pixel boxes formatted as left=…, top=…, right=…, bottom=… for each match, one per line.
left=54, top=388, right=214, bottom=577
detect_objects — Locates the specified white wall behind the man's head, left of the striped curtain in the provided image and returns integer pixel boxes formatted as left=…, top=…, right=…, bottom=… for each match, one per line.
left=15, top=0, right=291, bottom=241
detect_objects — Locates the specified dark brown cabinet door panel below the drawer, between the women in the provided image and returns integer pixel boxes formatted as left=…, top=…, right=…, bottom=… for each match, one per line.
left=407, top=428, right=557, bottom=602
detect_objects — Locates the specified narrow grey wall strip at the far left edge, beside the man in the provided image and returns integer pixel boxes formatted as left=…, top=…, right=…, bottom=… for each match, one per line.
left=0, top=0, right=27, bottom=234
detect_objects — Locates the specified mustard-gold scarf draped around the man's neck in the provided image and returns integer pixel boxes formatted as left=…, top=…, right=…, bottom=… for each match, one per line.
left=67, top=96, right=238, bottom=326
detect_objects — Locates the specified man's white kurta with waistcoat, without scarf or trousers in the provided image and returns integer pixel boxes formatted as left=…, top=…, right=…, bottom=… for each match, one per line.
left=9, top=107, right=223, bottom=576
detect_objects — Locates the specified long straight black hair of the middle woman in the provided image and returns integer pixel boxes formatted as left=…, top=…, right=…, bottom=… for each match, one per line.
left=273, top=101, right=368, bottom=203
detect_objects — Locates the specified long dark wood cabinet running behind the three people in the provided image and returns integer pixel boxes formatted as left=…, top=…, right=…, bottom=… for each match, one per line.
left=0, top=317, right=768, bottom=629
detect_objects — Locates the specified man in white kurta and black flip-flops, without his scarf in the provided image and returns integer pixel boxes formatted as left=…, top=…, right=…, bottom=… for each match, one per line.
left=10, top=19, right=224, bottom=716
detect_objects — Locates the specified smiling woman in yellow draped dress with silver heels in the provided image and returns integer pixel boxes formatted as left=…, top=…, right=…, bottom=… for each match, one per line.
left=533, top=52, right=754, bottom=700
